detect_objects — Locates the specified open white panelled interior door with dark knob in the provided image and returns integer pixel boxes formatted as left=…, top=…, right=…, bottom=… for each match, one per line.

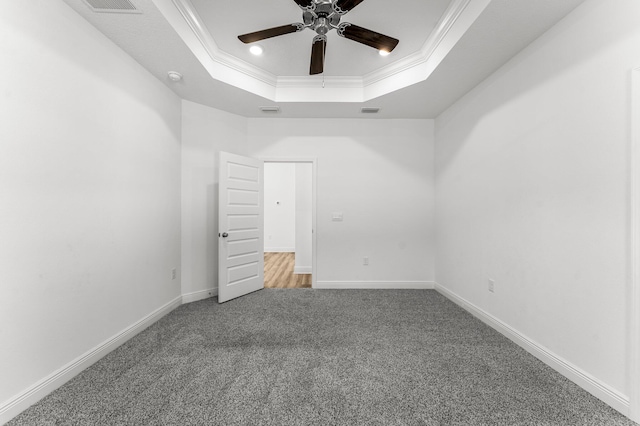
left=218, top=152, right=264, bottom=303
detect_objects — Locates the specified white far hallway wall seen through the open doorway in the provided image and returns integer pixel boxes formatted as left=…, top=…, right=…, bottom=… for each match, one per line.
left=264, top=162, right=296, bottom=253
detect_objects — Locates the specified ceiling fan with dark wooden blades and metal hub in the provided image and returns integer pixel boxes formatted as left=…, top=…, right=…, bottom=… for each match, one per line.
left=238, top=0, right=398, bottom=75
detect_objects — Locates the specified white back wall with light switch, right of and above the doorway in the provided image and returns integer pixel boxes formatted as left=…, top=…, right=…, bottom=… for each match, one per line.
left=248, top=118, right=434, bottom=287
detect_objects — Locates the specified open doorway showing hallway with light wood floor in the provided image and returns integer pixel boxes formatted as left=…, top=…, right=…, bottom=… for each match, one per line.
left=263, top=160, right=315, bottom=288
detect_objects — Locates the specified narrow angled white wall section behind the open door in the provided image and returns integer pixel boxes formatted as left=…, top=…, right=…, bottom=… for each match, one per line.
left=182, top=101, right=247, bottom=301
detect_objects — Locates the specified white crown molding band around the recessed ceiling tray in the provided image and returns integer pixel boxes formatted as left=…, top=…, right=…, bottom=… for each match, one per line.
left=152, top=0, right=491, bottom=102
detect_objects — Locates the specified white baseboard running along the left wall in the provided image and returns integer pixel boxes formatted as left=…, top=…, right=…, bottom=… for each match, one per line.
left=0, top=296, right=182, bottom=424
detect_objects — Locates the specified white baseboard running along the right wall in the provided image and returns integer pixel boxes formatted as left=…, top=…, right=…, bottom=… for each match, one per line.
left=435, top=283, right=629, bottom=416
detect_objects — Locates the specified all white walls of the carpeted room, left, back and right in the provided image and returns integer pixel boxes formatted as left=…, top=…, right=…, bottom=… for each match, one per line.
left=5, top=0, right=640, bottom=420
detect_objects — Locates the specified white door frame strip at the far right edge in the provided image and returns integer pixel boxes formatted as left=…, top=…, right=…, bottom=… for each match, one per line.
left=628, top=67, right=640, bottom=423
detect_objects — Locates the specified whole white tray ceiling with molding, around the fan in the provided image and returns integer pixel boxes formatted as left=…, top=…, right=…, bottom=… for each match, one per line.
left=58, top=0, right=584, bottom=118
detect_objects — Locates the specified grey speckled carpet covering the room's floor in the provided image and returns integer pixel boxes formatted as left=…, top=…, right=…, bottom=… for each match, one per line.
left=9, top=289, right=635, bottom=426
